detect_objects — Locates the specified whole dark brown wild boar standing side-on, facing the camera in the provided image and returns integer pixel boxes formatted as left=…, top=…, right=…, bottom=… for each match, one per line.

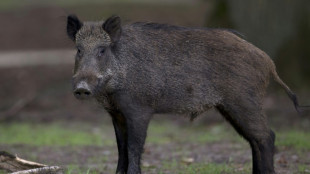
left=67, top=15, right=299, bottom=174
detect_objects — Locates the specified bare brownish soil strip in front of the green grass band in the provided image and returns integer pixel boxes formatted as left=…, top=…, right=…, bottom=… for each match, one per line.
left=0, top=140, right=310, bottom=174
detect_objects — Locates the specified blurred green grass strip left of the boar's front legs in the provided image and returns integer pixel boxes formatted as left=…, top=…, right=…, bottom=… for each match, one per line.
left=0, top=123, right=113, bottom=146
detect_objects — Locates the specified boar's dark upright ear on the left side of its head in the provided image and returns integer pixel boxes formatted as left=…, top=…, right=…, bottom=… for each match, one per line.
left=67, top=15, right=83, bottom=41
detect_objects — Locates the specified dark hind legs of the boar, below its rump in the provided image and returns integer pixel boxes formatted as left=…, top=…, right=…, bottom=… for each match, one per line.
left=217, top=103, right=275, bottom=174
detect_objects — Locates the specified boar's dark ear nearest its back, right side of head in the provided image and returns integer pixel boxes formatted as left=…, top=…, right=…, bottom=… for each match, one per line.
left=102, top=16, right=121, bottom=43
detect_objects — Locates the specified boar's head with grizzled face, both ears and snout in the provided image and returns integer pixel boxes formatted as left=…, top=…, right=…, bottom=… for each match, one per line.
left=67, top=15, right=121, bottom=99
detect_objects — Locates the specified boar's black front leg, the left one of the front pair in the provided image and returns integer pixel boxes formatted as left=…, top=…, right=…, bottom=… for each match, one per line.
left=110, top=112, right=128, bottom=174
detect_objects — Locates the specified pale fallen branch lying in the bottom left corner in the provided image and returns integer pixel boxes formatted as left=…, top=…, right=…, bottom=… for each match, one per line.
left=0, top=151, right=62, bottom=174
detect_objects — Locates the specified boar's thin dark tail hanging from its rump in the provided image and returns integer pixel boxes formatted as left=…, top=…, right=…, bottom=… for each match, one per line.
left=271, top=64, right=310, bottom=113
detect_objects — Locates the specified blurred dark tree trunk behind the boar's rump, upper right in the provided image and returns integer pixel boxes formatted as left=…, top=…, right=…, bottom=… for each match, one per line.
left=205, top=0, right=310, bottom=90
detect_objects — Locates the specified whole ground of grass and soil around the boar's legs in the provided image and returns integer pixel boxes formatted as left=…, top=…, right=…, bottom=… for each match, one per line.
left=0, top=116, right=310, bottom=174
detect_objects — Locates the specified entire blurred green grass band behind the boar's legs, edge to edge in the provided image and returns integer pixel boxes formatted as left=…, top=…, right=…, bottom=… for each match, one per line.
left=0, top=122, right=310, bottom=150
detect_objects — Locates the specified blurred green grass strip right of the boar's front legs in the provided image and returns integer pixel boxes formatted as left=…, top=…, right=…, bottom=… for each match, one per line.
left=147, top=122, right=310, bottom=150
